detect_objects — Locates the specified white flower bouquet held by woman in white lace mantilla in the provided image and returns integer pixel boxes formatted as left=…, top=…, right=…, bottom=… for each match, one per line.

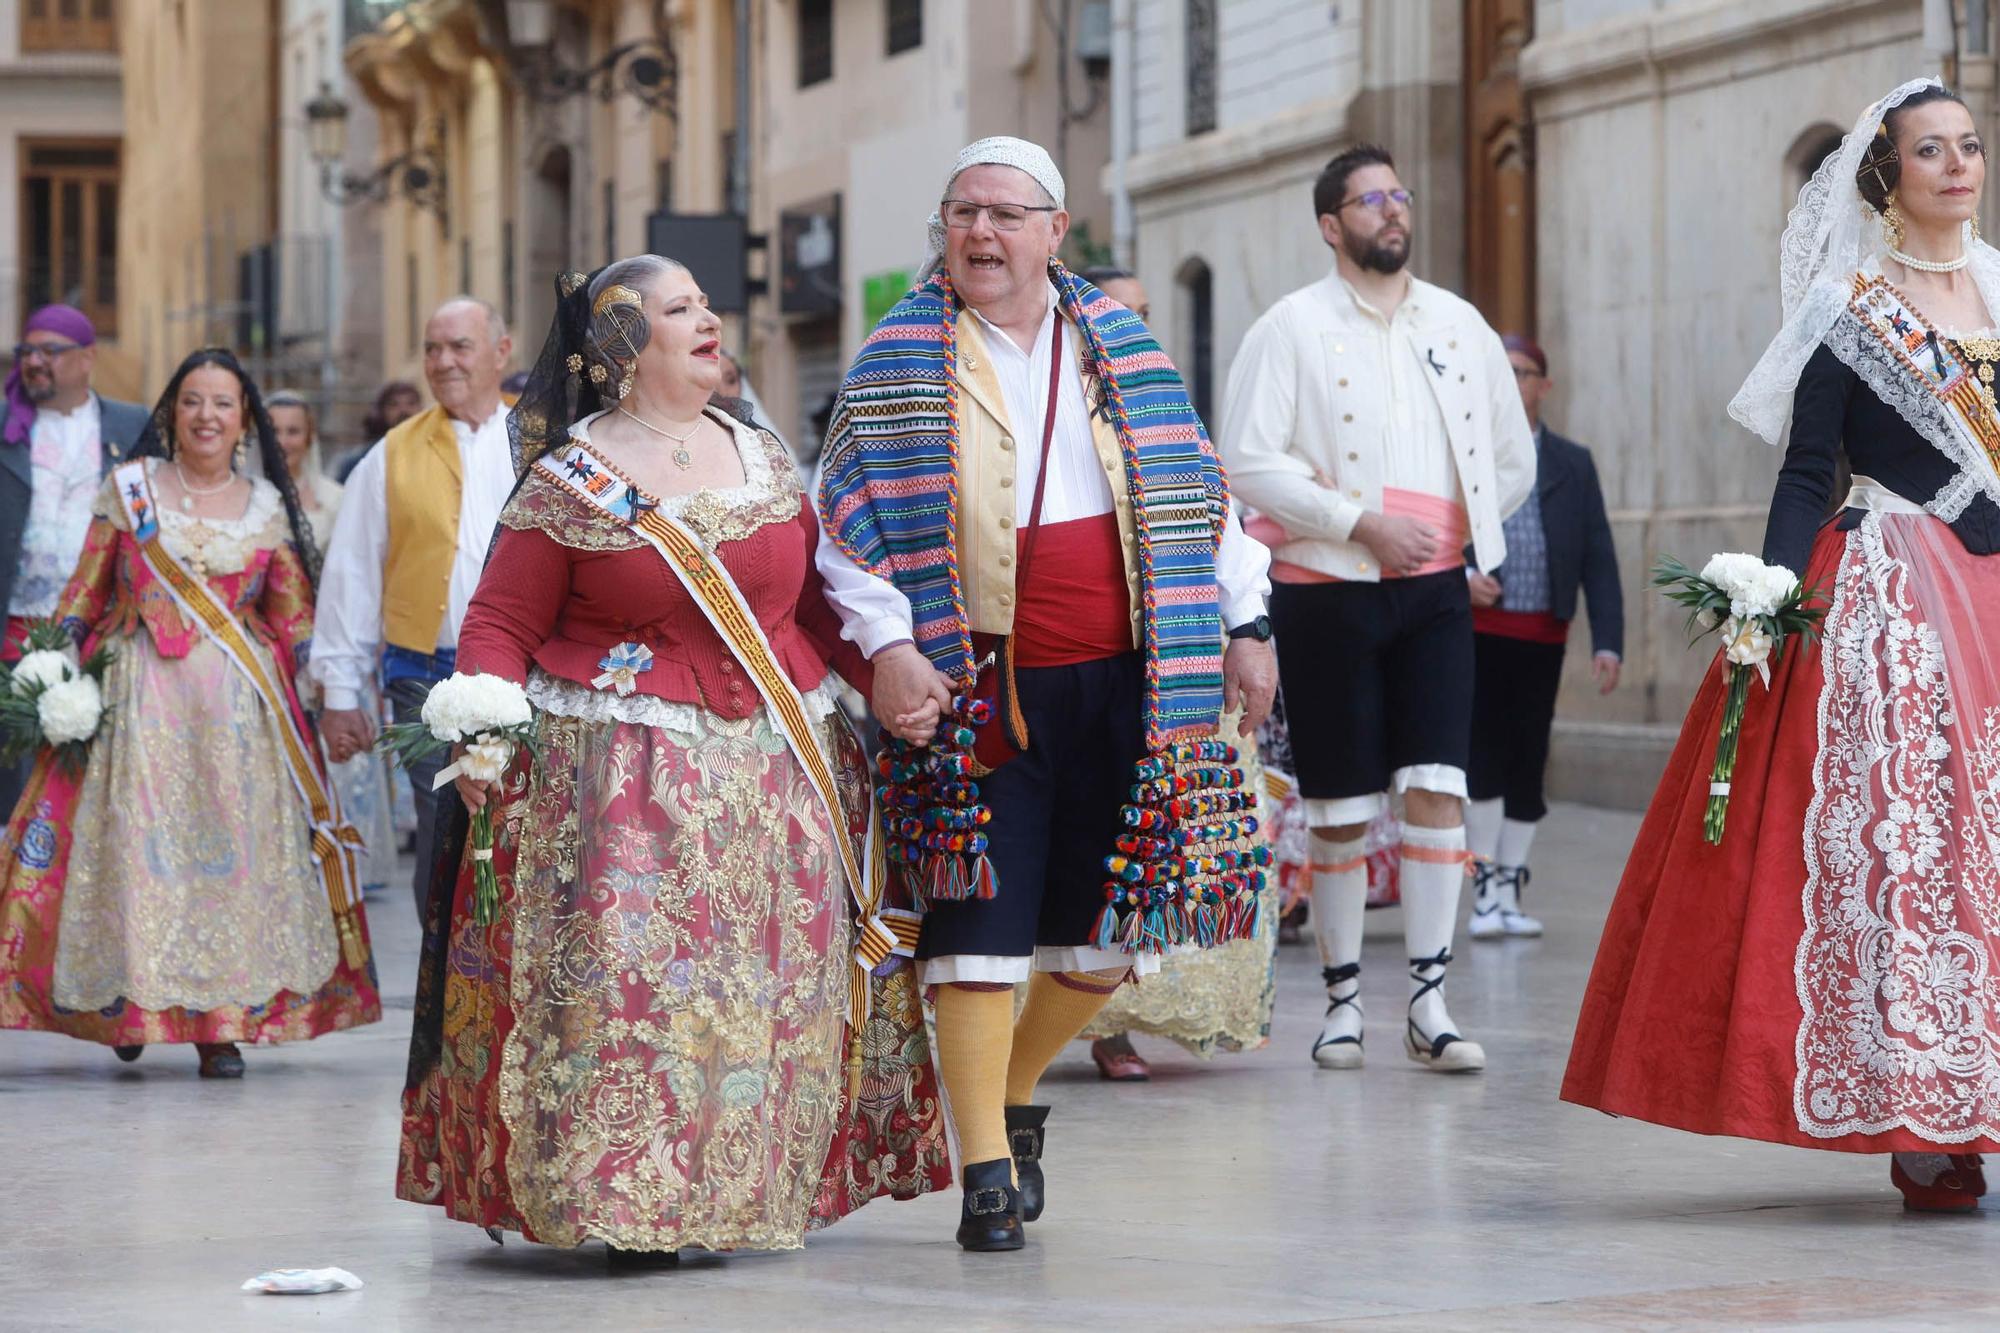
left=1652, top=552, right=1826, bottom=845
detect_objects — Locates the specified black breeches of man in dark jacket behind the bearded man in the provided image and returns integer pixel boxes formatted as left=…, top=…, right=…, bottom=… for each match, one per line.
left=1466, top=634, right=1564, bottom=825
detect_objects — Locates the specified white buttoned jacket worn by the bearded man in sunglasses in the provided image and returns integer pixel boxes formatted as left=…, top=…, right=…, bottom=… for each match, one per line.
left=1218, top=268, right=1534, bottom=582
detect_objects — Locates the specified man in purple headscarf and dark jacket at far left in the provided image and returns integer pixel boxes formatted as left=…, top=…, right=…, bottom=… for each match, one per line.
left=0, top=306, right=146, bottom=811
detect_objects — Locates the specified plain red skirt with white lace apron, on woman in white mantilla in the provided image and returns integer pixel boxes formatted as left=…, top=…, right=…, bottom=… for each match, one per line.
left=1562, top=514, right=2000, bottom=1153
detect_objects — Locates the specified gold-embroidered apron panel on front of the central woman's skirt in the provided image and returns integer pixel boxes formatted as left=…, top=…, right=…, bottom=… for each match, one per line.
left=500, top=709, right=852, bottom=1249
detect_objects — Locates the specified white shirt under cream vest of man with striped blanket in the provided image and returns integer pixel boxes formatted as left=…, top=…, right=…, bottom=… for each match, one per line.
left=816, top=286, right=1270, bottom=656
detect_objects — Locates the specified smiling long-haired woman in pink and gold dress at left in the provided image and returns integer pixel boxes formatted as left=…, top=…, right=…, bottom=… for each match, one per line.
left=0, top=348, right=382, bottom=1079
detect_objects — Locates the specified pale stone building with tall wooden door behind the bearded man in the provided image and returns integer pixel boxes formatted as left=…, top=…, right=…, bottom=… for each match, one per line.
left=1106, top=0, right=1952, bottom=805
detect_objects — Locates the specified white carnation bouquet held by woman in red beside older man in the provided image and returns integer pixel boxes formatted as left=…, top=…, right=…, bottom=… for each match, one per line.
left=380, top=673, right=534, bottom=925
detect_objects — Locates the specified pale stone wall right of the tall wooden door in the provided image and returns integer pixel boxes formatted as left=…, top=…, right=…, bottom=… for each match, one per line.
left=1520, top=0, right=1936, bottom=805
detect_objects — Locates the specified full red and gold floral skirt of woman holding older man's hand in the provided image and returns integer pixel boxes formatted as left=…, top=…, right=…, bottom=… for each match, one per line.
left=396, top=691, right=952, bottom=1251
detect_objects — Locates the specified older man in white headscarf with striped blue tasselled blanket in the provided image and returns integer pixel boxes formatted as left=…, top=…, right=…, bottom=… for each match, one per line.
left=818, top=136, right=1276, bottom=1251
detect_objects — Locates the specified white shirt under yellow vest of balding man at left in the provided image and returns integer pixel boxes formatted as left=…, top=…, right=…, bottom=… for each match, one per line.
left=312, top=404, right=514, bottom=709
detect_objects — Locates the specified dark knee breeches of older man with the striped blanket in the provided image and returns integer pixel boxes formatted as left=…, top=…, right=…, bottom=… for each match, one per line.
left=916, top=652, right=1146, bottom=959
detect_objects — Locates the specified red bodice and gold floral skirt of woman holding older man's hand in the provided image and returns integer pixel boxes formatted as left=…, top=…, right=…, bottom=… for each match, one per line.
left=398, top=416, right=950, bottom=1249
